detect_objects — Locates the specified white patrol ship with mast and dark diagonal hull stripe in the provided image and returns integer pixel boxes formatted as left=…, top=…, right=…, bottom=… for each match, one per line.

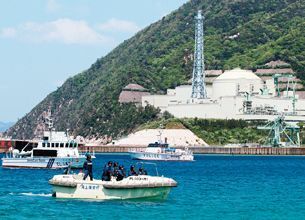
left=2, top=111, right=92, bottom=169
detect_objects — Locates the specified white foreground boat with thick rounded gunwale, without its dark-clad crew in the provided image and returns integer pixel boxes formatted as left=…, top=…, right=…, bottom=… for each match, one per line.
left=49, top=163, right=177, bottom=200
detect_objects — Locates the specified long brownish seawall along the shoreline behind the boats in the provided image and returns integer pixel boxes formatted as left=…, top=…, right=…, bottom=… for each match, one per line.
left=84, top=145, right=305, bottom=155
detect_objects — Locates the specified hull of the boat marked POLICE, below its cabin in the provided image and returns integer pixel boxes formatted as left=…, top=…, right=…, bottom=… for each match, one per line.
left=129, top=152, right=194, bottom=161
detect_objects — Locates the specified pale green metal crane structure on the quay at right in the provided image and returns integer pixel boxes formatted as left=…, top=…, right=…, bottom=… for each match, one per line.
left=257, top=116, right=301, bottom=147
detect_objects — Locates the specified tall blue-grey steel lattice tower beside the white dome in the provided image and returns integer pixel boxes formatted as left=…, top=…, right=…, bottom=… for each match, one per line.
left=191, top=10, right=207, bottom=99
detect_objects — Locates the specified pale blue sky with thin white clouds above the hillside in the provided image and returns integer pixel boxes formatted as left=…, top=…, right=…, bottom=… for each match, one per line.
left=0, top=0, right=187, bottom=122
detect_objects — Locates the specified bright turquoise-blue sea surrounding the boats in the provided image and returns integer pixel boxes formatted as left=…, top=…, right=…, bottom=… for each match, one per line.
left=0, top=154, right=305, bottom=220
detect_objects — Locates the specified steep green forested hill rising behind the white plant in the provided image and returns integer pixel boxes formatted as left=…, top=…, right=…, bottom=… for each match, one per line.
left=8, top=0, right=305, bottom=138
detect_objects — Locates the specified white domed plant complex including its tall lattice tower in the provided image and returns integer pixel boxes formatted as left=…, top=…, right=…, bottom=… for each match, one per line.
left=142, top=11, right=305, bottom=121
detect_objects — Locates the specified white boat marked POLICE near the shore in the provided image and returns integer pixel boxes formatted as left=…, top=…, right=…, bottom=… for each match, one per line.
left=129, top=142, right=194, bottom=161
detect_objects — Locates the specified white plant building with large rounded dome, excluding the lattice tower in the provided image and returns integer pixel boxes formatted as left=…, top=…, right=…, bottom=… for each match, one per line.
left=142, top=69, right=305, bottom=121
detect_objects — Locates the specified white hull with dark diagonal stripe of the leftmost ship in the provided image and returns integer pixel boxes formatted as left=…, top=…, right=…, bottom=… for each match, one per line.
left=2, top=157, right=86, bottom=169
